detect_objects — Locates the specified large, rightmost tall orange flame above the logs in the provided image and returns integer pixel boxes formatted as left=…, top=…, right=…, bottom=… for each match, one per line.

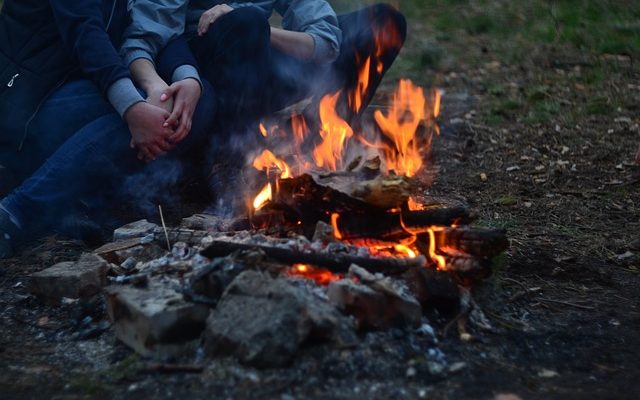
left=374, top=79, right=426, bottom=177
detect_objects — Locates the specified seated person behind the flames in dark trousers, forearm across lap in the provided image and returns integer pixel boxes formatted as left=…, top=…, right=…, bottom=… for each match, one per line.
left=187, top=0, right=406, bottom=119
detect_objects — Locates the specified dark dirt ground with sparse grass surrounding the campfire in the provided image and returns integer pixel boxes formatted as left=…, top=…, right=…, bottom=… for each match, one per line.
left=0, top=0, right=640, bottom=399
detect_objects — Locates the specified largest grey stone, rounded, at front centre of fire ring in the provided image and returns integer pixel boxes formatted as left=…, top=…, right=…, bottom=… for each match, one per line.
left=205, top=271, right=357, bottom=367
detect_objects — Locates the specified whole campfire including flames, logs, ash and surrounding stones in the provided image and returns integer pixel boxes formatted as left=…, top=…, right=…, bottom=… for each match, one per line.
left=32, top=55, right=508, bottom=366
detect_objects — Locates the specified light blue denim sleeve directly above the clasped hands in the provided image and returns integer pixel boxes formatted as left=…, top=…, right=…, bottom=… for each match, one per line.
left=120, top=0, right=188, bottom=65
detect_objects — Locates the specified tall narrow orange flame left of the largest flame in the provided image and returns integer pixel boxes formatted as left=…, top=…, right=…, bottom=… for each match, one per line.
left=313, top=92, right=353, bottom=171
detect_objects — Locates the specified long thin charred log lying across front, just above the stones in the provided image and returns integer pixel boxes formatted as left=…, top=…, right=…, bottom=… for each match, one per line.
left=200, top=240, right=427, bottom=274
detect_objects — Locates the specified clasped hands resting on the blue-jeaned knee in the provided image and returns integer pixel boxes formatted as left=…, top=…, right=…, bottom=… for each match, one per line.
left=125, top=79, right=201, bottom=162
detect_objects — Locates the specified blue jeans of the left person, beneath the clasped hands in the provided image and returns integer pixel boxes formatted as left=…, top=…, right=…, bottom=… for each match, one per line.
left=0, top=81, right=216, bottom=231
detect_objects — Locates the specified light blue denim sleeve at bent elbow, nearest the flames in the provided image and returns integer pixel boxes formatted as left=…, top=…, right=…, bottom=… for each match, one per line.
left=275, top=0, right=342, bottom=63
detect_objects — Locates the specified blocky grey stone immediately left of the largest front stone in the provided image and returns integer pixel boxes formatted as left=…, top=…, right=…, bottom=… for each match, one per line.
left=104, top=281, right=209, bottom=358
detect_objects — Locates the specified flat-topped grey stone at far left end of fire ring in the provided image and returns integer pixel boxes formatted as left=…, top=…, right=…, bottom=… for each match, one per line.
left=30, top=253, right=108, bottom=303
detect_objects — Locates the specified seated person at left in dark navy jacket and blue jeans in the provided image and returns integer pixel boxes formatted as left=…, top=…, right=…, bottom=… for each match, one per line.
left=0, top=0, right=214, bottom=258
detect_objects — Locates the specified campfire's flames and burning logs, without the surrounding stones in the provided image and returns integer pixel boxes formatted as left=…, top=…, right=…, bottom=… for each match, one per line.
left=240, top=78, right=507, bottom=283
